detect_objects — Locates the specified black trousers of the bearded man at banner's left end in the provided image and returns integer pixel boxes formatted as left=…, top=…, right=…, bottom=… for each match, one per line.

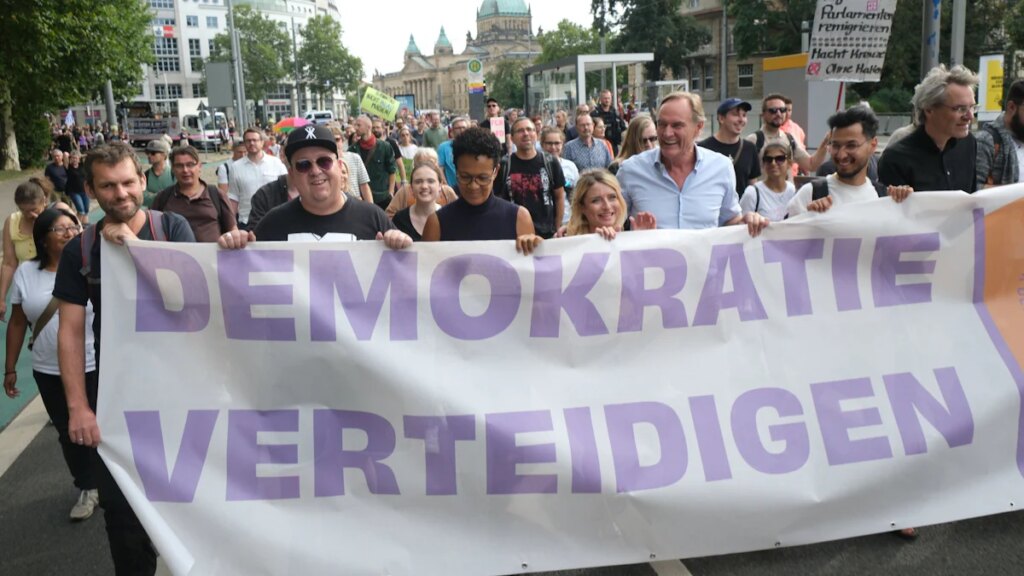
left=85, top=370, right=157, bottom=576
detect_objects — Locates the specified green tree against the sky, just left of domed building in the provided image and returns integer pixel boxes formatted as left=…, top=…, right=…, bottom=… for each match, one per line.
left=298, top=15, right=362, bottom=108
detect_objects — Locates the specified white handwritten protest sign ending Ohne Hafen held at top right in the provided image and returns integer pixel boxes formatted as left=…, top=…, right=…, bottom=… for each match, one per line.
left=807, top=0, right=896, bottom=82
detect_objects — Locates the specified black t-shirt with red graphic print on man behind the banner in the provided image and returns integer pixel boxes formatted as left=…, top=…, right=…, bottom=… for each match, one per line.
left=495, top=154, right=565, bottom=238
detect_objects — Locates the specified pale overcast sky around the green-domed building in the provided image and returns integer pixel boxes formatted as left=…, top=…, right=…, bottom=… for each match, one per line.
left=338, top=0, right=593, bottom=80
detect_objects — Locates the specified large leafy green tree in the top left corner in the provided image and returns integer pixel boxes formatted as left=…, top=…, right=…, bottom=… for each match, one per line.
left=0, top=0, right=154, bottom=170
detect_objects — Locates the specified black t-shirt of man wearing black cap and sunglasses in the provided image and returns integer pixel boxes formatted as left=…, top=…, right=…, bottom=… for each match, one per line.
left=253, top=198, right=394, bottom=242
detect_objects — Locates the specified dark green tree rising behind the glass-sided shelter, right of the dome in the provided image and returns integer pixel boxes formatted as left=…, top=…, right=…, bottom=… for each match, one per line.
left=591, top=0, right=712, bottom=99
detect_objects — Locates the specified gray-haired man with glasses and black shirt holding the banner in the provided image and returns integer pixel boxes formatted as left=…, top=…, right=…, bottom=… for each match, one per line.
left=879, top=65, right=978, bottom=194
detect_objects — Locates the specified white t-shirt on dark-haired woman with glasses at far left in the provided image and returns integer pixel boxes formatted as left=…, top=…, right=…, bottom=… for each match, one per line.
left=10, top=260, right=96, bottom=376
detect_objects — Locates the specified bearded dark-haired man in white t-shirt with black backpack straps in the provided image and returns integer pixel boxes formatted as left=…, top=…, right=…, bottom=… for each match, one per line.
left=786, top=106, right=912, bottom=216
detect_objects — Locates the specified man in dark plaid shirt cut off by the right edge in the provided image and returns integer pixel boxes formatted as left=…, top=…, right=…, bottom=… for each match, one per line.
left=974, top=80, right=1024, bottom=189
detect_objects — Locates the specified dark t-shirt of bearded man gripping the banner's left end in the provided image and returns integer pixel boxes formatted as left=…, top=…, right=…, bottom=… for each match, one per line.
left=53, top=212, right=196, bottom=367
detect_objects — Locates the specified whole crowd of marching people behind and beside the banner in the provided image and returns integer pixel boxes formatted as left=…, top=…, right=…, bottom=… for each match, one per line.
left=0, top=61, right=1024, bottom=574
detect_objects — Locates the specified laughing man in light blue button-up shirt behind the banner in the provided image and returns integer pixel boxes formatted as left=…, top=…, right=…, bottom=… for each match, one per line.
left=614, top=92, right=768, bottom=236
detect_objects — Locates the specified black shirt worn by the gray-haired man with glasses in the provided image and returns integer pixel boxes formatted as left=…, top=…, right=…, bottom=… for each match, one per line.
left=879, top=126, right=978, bottom=194
